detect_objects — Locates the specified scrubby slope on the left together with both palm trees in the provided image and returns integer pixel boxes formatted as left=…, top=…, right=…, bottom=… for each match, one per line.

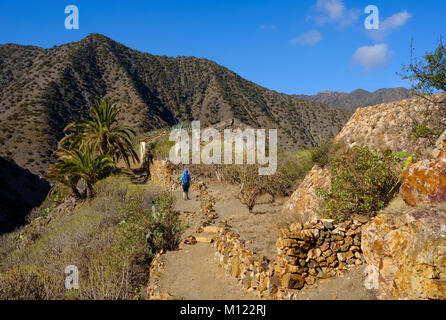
left=0, top=100, right=186, bottom=299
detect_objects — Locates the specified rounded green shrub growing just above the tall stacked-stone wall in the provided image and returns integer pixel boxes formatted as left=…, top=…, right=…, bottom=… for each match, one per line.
left=317, top=147, right=401, bottom=221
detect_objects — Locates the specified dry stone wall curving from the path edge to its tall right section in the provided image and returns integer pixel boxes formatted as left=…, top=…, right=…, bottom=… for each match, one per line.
left=214, top=216, right=367, bottom=299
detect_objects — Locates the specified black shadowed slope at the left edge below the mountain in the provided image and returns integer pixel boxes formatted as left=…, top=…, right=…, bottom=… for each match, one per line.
left=0, top=157, right=51, bottom=235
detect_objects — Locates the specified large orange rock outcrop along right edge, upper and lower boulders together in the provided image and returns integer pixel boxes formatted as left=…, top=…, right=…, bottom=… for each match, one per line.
left=361, top=128, right=446, bottom=299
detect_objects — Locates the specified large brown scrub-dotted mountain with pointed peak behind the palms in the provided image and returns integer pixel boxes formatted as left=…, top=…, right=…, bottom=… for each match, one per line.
left=0, top=34, right=351, bottom=175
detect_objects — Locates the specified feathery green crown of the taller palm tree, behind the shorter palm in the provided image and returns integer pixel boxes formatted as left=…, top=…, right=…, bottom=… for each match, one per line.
left=60, top=100, right=139, bottom=168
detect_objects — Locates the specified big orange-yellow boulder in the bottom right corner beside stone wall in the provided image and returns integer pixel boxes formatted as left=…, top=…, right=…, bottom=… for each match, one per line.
left=361, top=207, right=446, bottom=299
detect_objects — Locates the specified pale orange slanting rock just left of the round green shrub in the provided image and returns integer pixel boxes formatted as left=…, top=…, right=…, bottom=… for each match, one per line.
left=282, top=165, right=330, bottom=223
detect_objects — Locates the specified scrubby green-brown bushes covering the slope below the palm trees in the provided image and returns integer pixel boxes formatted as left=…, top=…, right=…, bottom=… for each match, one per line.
left=0, top=177, right=183, bottom=300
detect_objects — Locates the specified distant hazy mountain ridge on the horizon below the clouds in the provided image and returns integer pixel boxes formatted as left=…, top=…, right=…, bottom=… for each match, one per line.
left=296, top=88, right=412, bottom=111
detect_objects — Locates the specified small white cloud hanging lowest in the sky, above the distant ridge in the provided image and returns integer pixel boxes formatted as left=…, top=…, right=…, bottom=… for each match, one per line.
left=353, top=43, right=393, bottom=71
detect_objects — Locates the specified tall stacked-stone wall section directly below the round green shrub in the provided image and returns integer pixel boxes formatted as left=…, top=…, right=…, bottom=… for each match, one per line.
left=272, top=216, right=367, bottom=289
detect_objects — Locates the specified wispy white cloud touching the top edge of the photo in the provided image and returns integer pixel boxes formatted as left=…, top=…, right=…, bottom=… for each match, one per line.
left=315, top=0, right=361, bottom=27
